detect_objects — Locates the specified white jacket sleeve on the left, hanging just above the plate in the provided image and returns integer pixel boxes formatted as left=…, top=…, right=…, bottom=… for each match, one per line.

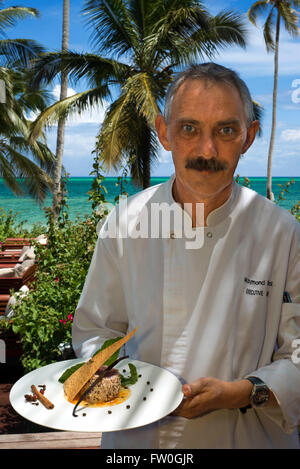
left=72, top=218, right=128, bottom=358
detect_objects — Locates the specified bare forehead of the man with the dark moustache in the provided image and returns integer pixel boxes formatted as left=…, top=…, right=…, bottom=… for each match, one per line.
left=171, top=79, right=246, bottom=121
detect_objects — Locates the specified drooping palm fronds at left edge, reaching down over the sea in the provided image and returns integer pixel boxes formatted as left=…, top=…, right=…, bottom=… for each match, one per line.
left=0, top=68, right=54, bottom=203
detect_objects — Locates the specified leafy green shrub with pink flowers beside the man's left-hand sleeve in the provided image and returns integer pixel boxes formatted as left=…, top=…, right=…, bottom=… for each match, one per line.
left=7, top=166, right=106, bottom=372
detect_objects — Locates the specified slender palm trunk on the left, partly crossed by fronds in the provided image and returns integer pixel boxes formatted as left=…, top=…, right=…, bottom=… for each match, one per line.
left=52, top=0, right=70, bottom=220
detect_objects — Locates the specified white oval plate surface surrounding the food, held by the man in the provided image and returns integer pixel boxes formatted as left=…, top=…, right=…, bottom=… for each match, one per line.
left=9, top=358, right=183, bottom=432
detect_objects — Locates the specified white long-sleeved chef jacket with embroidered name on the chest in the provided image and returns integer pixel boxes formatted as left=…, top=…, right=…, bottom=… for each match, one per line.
left=73, top=176, right=300, bottom=449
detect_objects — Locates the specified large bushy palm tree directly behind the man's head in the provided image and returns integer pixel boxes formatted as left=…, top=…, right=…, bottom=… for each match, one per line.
left=32, top=0, right=250, bottom=188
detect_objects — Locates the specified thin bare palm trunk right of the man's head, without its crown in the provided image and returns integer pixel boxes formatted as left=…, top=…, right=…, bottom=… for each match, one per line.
left=267, top=11, right=280, bottom=201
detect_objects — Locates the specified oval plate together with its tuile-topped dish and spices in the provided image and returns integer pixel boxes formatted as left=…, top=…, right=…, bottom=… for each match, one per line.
left=10, top=330, right=183, bottom=432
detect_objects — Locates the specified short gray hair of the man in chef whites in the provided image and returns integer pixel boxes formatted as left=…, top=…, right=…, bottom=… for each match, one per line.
left=164, top=62, right=255, bottom=125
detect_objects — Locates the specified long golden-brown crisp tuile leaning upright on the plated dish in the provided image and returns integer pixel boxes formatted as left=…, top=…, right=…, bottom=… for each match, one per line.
left=64, top=327, right=137, bottom=401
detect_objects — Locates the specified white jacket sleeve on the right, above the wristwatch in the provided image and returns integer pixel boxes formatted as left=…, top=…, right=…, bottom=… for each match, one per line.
left=249, top=225, right=300, bottom=433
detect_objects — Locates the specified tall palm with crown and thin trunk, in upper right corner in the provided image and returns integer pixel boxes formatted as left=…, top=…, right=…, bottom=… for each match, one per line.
left=248, top=0, right=300, bottom=201
